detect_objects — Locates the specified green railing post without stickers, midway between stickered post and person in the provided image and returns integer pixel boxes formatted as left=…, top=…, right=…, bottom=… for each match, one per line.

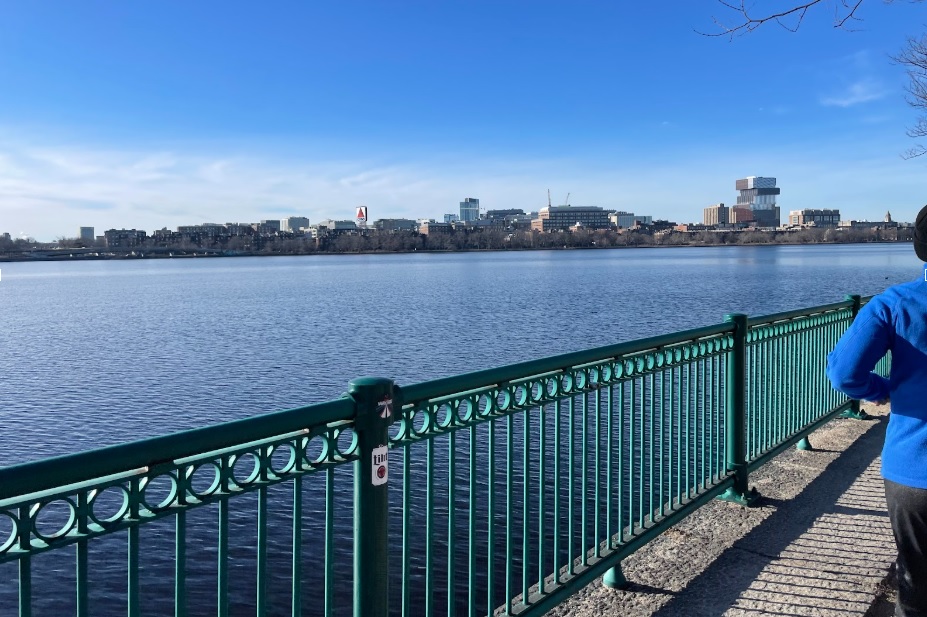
left=720, top=313, right=759, bottom=506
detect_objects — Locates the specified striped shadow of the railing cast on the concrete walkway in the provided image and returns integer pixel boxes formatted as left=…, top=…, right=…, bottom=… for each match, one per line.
left=648, top=410, right=894, bottom=617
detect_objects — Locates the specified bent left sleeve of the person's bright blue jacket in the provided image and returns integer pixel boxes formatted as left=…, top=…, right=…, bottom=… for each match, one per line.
left=827, top=297, right=895, bottom=401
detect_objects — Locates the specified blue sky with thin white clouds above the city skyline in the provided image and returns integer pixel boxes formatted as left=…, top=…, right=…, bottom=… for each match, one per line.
left=0, top=0, right=927, bottom=240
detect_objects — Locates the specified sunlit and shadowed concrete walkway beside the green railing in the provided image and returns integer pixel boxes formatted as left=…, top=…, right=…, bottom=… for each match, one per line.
left=548, top=406, right=895, bottom=617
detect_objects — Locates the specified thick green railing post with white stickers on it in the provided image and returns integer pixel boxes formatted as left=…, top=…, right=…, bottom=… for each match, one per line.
left=348, top=377, right=393, bottom=617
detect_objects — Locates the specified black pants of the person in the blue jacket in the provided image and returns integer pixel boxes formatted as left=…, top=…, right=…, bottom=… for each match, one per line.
left=885, top=480, right=927, bottom=617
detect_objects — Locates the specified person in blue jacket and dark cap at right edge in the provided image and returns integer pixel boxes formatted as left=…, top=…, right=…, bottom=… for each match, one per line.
left=827, top=206, right=927, bottom=617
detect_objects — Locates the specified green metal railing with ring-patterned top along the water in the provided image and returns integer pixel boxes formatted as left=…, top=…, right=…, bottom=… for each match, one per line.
left=0, top=296, right=890, bottom=617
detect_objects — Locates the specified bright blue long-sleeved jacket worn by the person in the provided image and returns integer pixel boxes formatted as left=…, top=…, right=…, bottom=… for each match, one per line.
left=827, top=269, right=927, bottom=489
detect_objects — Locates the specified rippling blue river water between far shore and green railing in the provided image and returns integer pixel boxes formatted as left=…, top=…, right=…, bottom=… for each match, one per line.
left=0, top=244, right=921, bottom=616
